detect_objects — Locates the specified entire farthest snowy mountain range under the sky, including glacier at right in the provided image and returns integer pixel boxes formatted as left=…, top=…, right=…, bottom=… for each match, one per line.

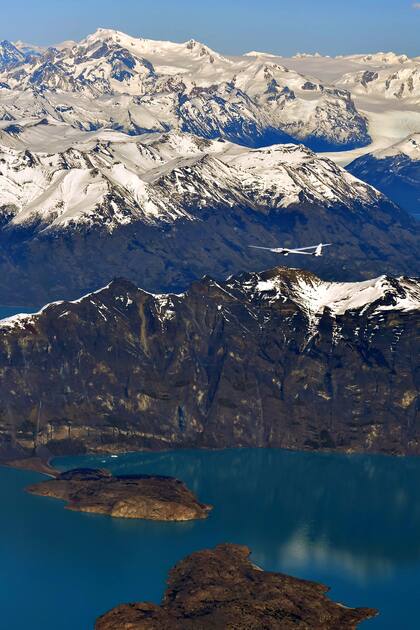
left=0, top=29, right=420, bottom=164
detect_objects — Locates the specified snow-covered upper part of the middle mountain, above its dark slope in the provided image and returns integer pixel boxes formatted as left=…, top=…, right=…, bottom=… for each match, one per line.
left=0, top=131, right=380, bottom=231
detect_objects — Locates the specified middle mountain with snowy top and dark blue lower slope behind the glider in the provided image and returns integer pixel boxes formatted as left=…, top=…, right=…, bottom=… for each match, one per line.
left=0, top=130, right=420, bottom=306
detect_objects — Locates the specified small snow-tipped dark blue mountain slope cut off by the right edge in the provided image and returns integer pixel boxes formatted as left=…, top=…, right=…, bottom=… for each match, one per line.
left=347, top=133, right=420, bottom=219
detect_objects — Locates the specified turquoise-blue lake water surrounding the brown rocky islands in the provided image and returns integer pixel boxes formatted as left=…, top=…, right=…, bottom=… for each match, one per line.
left=0, top=449, right=420, bottom=630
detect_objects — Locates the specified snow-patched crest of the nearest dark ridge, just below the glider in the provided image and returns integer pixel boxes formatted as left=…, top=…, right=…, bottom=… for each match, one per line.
left=0, top=268, right=420, bottom=331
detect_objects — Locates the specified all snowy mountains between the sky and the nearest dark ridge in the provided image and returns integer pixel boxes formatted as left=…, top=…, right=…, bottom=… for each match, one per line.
left=0, top=29, right=420, bottom=306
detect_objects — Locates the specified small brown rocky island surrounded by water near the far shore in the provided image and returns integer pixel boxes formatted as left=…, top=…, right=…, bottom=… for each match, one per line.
left=27, top=468, right=211, bottom=521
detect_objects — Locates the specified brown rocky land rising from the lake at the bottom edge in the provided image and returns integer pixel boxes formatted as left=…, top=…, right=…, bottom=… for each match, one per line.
left=96, top=544, right=377, bottom=630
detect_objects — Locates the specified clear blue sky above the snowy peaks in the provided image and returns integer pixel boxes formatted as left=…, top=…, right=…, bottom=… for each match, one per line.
left=0, top=0, right=420, bottom=55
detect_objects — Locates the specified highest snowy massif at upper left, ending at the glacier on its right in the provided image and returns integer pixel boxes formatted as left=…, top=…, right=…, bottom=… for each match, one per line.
left=0, top=29, right=369, bottom=149
